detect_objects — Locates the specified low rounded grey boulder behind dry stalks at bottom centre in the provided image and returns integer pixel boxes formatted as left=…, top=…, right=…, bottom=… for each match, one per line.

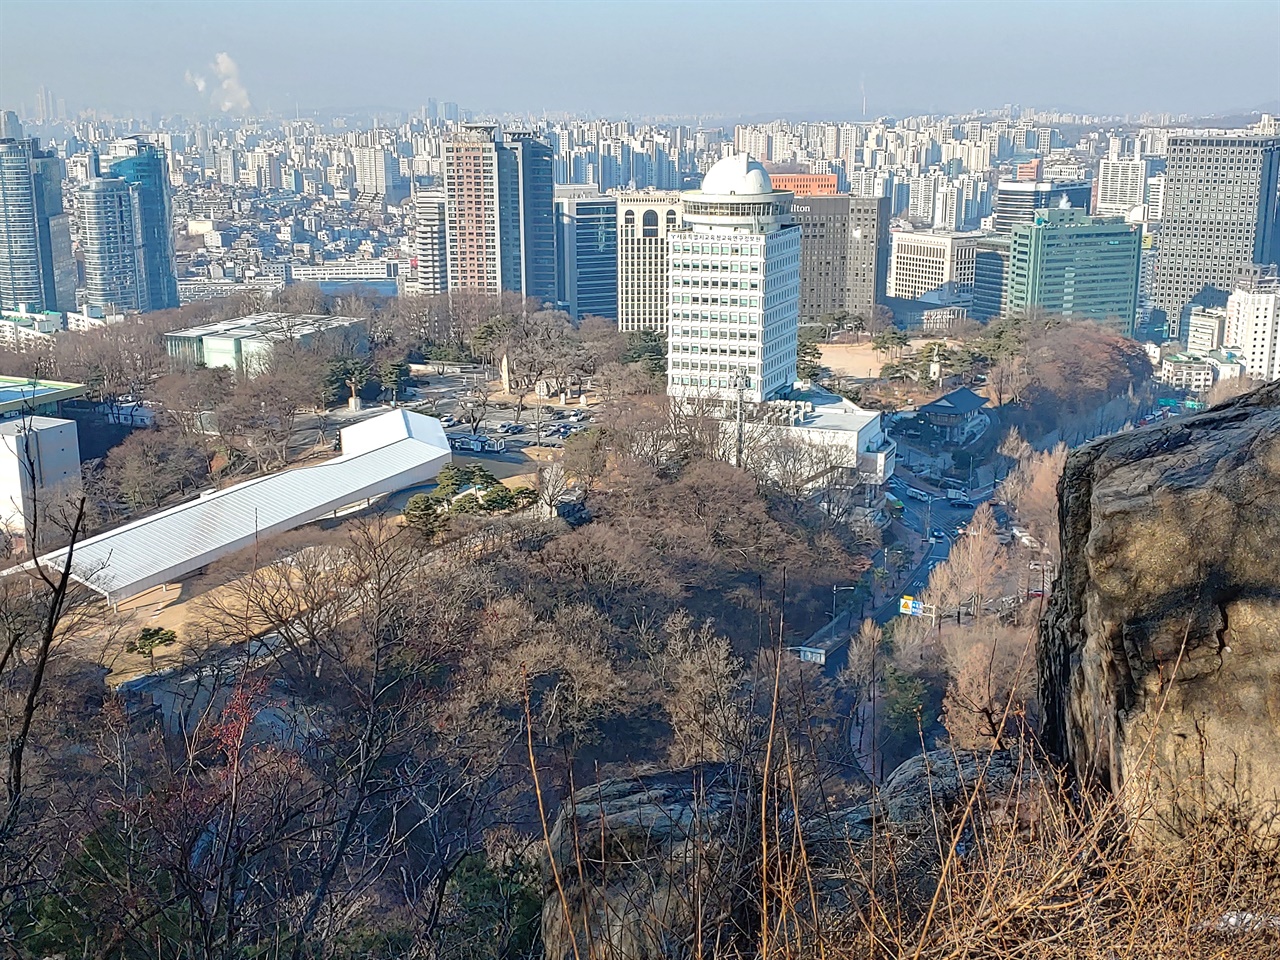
left=543, top=764, right=760, bottom=960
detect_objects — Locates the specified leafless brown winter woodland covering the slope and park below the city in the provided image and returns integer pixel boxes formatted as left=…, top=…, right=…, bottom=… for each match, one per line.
left=0, top=288, right=1239, bottom=960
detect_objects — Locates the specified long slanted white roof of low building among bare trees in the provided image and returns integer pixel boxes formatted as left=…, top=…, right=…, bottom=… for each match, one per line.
left=44, top=411, right=451, bottom=603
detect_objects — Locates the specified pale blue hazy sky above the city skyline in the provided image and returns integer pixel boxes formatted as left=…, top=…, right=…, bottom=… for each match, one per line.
left=0, top=0, right=1280, bottom=119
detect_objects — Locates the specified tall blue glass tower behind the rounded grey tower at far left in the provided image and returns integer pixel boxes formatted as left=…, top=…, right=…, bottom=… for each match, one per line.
left=110, top=140, right=179, bottom=310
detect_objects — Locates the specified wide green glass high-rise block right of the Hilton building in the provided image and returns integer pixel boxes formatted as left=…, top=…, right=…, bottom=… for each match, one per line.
left=1005, top=209, right=1142, bottom=335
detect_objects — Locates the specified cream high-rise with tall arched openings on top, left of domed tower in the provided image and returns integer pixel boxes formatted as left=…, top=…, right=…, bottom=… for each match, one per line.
left=617, top=191, right=684, bottom=333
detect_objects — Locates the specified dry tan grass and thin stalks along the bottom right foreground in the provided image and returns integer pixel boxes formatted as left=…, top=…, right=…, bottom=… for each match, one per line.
left=547, top=742, right=1280, bottom=960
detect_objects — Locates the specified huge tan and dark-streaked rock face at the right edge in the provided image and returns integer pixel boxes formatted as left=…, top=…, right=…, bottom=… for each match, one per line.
left=1039, top=384, right=1280, bottom=849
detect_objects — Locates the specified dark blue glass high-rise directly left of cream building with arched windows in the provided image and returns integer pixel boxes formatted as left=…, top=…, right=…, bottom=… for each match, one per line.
left=556, top=187, right=618, bottom=320
